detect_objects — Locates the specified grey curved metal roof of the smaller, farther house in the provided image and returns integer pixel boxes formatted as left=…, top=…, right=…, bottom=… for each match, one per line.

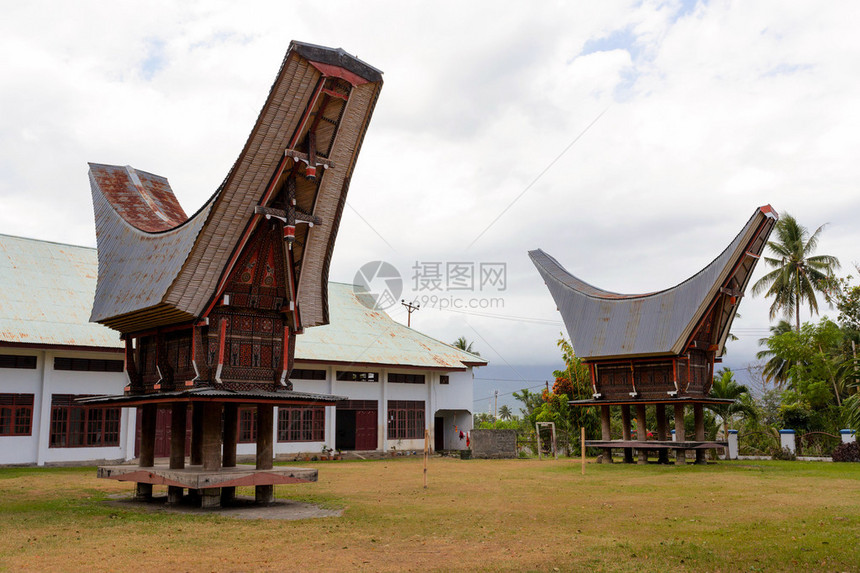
left=529, top=205, right=777, bottom=360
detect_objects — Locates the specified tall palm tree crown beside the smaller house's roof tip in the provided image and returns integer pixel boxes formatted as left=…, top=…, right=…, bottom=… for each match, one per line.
left=752, top=214, right=839, bottom=332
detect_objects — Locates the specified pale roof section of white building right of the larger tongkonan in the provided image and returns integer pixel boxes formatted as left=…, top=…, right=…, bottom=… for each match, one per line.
left=296, top=283, right=487, bottom=371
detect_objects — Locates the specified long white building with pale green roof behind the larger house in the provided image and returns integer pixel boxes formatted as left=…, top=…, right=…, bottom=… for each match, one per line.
left=0, top=235, right=486, bottom=465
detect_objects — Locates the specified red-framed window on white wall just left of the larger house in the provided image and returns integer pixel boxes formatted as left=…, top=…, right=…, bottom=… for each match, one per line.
left=48, top=394, right=122, bottom=448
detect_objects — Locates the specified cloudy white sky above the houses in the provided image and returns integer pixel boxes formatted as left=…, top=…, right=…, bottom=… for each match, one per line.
left=0, top=0, right=860, bottom=404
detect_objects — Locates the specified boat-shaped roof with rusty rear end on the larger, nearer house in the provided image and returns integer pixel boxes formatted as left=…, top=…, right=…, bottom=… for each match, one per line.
left=90, top=42, right=382, bottom=332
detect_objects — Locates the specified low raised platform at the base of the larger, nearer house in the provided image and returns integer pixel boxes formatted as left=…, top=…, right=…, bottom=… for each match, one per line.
left=97, top=464, right=318, bottom=489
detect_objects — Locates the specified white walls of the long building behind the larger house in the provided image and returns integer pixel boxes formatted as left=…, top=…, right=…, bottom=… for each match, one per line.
left=0, top=348, right=473, bottom=465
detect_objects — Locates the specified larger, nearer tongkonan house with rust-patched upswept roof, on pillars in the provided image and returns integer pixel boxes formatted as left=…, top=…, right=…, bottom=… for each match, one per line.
left=81, top=42, right=382, bottom=507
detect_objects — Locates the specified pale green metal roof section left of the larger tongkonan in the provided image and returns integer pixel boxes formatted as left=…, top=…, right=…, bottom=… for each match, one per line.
left=0, top=235, right=121, bottom=348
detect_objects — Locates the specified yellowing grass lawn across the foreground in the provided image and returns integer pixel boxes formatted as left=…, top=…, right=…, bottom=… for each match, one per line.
left=0, top=457, right=860, bottom=571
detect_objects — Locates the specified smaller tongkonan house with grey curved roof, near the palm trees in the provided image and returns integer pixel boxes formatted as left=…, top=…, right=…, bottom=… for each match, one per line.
left=529, top=205, right=778, bottom=464
